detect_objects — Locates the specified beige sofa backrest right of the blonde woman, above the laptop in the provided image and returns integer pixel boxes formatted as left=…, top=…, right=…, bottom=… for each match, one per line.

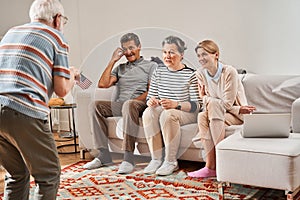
left=242, top=74, right=300, bottom=113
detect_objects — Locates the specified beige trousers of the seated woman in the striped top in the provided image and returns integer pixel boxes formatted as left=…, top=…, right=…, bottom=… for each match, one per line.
left=143, top=106, right=197, bottom=162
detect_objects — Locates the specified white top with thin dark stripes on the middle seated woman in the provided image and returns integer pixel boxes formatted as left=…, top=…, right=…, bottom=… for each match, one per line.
left=147, top=65, right=201, bottom=111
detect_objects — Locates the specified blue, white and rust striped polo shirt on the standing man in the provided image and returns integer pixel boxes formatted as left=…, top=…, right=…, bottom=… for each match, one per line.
left=0, top=22, right=70, bottom=119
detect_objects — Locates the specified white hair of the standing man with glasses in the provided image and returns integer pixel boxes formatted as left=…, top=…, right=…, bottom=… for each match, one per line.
left=29, top=0, right=64, bottom=22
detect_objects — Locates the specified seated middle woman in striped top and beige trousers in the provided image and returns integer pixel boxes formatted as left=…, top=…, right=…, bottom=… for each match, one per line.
left=143, top=36, right=200, bottom=175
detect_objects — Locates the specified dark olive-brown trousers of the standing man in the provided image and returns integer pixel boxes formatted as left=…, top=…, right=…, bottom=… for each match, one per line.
left=0, top=105, right=61, bottom=200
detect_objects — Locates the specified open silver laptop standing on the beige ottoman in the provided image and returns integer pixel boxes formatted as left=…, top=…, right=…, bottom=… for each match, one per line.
left=241, top=113, right=291, bottom=138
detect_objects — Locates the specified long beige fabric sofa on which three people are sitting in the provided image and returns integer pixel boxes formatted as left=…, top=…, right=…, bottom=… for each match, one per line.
left=75, top=74, right=300, bottom=161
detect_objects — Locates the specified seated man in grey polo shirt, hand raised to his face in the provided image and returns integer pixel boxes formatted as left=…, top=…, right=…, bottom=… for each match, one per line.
left=83, top=33, right=157, bottom=174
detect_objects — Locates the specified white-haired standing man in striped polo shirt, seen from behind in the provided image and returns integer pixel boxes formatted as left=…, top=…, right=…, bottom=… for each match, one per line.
left=0, top=0, right=79, bottom=200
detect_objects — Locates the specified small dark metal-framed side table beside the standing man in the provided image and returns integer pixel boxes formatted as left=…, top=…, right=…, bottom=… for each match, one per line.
left=49, top=103, right=79, bottom=154
